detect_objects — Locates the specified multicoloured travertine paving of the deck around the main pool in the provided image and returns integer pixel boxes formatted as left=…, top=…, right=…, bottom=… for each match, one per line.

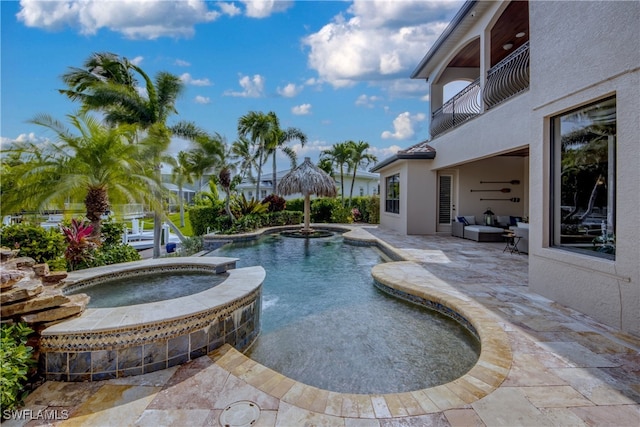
left=3, top=227, right=640, bottom=427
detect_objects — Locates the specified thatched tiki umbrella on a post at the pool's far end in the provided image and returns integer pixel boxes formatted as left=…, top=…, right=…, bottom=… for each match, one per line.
left=278, top=157, right=337, bottom=233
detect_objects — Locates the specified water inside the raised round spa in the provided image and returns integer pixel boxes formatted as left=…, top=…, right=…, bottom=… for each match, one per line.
left=69, top=271, right=228, bottom=308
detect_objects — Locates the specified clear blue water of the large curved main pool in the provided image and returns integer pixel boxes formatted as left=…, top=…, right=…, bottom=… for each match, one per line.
left=210, top=235, right=480, bottom=394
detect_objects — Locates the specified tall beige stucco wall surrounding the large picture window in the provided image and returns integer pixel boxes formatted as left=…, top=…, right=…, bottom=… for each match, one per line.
left=529, top=2, right=640, bottom=336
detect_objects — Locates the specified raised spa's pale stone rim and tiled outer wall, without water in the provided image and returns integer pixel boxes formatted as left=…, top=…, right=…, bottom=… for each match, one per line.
left=39, top=257, right=265, bottom=381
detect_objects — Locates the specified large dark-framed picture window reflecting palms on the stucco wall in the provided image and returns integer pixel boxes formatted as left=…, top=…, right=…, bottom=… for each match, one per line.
left=551, top=98, right=616, bottom=259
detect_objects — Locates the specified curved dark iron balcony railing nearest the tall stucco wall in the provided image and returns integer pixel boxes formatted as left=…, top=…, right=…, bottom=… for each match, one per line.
left=482, top=42, right=529, bottom=109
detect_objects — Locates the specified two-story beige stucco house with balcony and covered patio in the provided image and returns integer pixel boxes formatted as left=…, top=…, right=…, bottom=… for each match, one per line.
left=372, top=1, right=640, bottom=336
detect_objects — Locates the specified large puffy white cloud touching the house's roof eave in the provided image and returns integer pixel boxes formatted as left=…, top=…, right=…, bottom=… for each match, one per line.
left=303, top=0, right=461, bottom=87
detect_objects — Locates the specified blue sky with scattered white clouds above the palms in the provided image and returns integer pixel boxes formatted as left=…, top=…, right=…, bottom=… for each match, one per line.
left=0, top=0, right=462, bottom=171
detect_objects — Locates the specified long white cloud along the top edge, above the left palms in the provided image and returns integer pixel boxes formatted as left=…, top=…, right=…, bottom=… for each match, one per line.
left=17, top=0, right=220, bottom=40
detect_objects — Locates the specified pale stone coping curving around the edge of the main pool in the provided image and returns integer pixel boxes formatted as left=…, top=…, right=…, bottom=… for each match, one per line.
left=202, top=224, right=513, bottom=419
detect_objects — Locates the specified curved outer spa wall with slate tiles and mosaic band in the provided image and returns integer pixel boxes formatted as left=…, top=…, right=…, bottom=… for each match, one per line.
left=39, top=288, right=261, bottom=381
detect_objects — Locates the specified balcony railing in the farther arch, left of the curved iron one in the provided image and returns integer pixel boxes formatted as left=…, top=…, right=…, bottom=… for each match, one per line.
left=429, top=78, right=482, bottom=138
